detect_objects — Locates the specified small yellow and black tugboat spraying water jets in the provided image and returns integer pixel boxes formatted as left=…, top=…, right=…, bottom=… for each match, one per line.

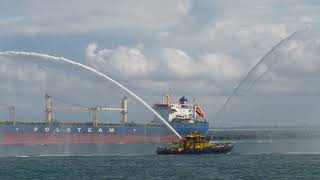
left=157, top=131, right=233, bottom=155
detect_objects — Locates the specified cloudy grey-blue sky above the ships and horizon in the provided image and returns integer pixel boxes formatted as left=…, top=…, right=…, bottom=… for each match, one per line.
left=0, top=0, right=320, bottom=126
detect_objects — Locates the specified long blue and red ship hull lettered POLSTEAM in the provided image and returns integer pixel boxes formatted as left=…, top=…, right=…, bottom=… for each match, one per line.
left=0, top=123, right=208, bottom=145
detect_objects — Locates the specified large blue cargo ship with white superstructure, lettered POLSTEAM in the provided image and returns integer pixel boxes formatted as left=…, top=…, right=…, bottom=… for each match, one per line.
left=0, top=94, right=209, bottom=145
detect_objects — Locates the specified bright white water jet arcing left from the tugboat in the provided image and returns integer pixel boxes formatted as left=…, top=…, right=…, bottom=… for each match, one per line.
left=0, top=51, right=182, bottom=139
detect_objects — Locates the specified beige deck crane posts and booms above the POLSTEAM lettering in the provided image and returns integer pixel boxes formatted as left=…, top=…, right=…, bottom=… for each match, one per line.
left=45, top=94, right=128, bottom=126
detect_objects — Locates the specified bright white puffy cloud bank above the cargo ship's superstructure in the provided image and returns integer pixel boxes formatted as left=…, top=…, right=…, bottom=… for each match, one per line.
left=86, top=44, right=243, bottom=83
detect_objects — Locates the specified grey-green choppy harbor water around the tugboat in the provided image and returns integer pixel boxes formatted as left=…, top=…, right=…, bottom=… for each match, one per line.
left=0, top=138, right=320, bottom=179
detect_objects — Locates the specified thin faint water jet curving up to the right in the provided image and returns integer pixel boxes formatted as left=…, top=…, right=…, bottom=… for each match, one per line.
left=217, top=31, right=303, bottom=121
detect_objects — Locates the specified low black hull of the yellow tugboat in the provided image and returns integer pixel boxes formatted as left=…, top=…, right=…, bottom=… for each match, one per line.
left=157, top=143, right=233, bottom=155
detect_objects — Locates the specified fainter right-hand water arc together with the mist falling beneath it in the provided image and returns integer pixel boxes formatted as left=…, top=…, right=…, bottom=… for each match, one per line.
left=217, top=31, right=303, bottom=122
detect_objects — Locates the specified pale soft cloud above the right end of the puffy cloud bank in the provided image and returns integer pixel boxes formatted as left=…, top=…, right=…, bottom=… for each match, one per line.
left=185, top=19, right=291, bottom=59
